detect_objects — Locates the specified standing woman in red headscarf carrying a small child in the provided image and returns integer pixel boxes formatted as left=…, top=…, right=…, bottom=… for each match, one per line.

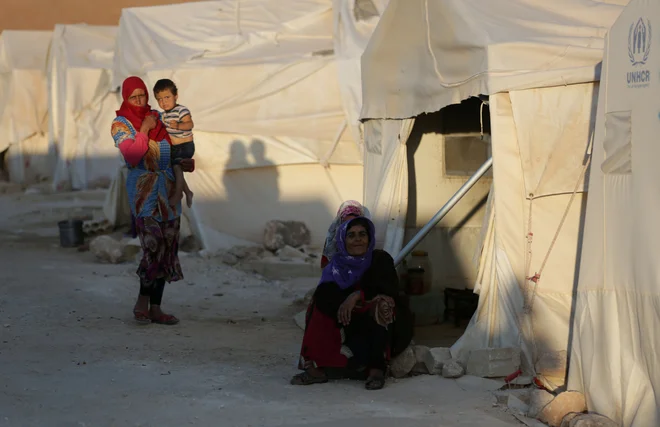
left=112, top=77, right=183, bottom=325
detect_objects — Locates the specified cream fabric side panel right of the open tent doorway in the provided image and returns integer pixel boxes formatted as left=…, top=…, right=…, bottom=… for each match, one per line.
left=451, top=88, right=597, bottom=389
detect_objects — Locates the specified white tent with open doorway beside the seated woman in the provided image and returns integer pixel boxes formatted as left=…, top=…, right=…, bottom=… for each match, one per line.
left=362, top=0, right=626, bottom=385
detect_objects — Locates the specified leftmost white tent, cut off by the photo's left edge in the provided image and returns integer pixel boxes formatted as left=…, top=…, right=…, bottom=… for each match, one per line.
left=0, top=30, right=52, bottom=184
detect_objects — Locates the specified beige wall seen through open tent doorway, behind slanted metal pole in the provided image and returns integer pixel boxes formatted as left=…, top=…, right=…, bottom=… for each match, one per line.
left=406, top=99, right=492, bottom=291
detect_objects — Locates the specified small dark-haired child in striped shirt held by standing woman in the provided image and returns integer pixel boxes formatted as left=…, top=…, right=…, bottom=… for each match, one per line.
left=154, top=79, right=195, bottom=207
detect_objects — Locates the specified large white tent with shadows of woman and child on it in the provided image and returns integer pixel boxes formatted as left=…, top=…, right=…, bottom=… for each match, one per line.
left=106, top=0, right=376, bottom=250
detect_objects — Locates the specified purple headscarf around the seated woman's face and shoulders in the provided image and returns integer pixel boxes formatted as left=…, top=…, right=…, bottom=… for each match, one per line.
left=319, top=216, right=376, bottom=289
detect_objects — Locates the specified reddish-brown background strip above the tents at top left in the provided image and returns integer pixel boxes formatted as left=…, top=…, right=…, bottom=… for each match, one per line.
left=0, top=0, right=201, bottom=31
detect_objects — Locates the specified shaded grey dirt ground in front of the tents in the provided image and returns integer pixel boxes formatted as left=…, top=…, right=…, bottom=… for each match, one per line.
left=0, top=192, right=520, bottom=427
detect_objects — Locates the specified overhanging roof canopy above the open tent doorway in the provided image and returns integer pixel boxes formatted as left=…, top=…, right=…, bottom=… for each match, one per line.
left=361, top=0, right=628, bottom=120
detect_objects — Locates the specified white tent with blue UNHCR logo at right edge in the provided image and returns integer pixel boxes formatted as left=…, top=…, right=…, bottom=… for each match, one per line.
left=568, top=0, right=660, bottom=427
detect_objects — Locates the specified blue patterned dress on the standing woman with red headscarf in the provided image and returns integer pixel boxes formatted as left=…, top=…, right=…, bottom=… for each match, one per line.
left=112, top=116, right=183, bottom=286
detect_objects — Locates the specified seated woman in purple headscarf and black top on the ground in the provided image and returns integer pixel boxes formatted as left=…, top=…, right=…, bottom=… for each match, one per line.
left=291, top=217, right=413, bottom=390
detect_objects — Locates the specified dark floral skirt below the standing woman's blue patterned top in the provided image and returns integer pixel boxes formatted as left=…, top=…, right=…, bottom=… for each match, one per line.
left=135, top=217, right=183, bottom=283
